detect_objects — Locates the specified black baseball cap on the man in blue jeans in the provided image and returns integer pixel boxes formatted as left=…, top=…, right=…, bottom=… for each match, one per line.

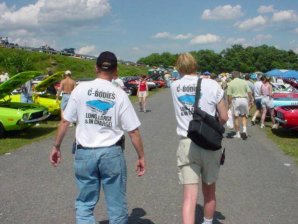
left=96, top=51, right=118, bottom=72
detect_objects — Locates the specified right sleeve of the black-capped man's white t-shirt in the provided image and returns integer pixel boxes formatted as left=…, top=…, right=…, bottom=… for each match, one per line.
left=120, top=94, right=141, bottom=131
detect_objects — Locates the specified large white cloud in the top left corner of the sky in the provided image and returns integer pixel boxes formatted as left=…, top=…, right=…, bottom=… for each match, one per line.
left=0, top=0, right=111, bottom=29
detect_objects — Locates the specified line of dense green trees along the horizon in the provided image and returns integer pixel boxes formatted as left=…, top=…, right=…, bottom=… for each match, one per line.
left=138, top=45, right=298, bottom=73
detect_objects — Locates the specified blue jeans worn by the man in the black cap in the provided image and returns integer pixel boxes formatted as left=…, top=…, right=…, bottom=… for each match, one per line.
left=74, top=146, right=128, bottom=224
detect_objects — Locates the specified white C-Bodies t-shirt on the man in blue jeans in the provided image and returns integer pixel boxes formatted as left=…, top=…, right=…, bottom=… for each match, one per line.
left=64, top=79, right=141, bottom=147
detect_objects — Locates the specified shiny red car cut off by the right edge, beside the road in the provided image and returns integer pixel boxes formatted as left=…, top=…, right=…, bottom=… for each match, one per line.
left=274, top=105, right=298, bottom=130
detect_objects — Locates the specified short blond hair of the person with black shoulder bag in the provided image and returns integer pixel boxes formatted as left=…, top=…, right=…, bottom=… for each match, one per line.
left=175, top=53, right=198, bottom=75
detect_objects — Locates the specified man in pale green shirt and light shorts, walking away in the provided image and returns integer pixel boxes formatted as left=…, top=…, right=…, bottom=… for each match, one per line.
left=227, top=71, right=253, bottom=139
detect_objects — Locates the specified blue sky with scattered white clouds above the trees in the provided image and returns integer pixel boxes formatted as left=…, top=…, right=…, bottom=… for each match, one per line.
left=0, top=0, right=298, bottom=61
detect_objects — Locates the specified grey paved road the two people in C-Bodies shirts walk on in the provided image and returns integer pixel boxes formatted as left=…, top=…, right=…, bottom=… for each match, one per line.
left=0, top=89, right=298, bottom=224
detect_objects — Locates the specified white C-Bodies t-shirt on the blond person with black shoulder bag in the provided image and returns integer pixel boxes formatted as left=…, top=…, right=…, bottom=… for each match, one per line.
left=171, top=75, right=224, bottom=137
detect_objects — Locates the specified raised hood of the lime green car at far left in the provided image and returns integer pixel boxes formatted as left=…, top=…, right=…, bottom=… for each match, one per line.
left=0, top=71, right=41, bottom=99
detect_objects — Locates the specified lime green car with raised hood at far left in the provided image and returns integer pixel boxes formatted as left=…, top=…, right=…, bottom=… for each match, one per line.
left=0, top=71, right=50, bottom=136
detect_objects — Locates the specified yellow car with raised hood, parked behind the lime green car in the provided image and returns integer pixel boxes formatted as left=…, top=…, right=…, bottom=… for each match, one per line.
left=5, top=72, right=64, bottom=116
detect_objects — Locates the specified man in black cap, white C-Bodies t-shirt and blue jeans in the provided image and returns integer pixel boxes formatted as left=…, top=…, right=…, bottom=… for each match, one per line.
left=49, top=51, right=145, bottom=224
